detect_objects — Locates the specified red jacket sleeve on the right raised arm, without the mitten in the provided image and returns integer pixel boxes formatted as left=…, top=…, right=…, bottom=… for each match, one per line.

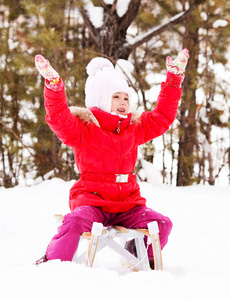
left=137, top=75, right=182, bottom=145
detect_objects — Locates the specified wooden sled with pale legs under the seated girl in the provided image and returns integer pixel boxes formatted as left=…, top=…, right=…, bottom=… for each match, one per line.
left=54, top=215, right=163, bottom=271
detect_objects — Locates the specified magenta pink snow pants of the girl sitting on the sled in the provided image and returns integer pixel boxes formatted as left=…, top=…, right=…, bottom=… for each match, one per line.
left=46, top=206, right=172, bottom=261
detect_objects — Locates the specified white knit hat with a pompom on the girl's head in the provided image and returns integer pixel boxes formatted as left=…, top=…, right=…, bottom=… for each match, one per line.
left=85, top=57, right=131, bottom=112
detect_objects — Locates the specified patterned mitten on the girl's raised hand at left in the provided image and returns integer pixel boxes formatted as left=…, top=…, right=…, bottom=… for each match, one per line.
left=35, top=55, right=59, bottom=84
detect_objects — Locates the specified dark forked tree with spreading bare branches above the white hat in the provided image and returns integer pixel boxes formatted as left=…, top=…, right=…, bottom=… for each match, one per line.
left=79, top=0, right=199, bottom=60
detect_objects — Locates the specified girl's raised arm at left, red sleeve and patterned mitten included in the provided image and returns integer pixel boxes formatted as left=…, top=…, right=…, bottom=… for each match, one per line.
left=35, top=55, right=85, bottom=147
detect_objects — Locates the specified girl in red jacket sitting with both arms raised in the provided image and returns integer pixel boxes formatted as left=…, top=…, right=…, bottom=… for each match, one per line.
left=35, top=49, right=189, bottom=268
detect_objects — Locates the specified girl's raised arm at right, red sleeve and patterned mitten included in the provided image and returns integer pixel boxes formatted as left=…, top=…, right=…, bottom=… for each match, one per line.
left=137, top=49, right=189, bottom=145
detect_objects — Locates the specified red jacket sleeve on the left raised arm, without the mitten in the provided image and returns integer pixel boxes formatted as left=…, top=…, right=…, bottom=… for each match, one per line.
left=44, top=81, right=85, bottom=147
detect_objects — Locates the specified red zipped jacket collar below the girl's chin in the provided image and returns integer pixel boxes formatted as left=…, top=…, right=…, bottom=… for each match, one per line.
left=90, top=107, right=132, bottom=133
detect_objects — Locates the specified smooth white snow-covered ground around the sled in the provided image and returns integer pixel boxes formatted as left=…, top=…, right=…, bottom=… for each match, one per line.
left=0, top=179, right=230, bottom=300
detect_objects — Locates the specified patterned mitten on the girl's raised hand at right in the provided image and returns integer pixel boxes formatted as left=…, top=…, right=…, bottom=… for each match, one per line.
left=166, top=48, right=189, bottom=75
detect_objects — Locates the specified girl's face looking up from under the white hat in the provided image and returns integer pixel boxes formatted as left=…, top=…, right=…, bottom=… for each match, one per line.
left=111, top=92, right=129, bottom=116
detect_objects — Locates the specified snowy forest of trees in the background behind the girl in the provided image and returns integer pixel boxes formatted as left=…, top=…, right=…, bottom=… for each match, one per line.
left=0, top=0, right=230, bottom=187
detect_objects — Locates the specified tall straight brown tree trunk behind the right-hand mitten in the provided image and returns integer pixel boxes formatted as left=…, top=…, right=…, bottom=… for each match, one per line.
left=177, top=9, right=200, bottom=186
